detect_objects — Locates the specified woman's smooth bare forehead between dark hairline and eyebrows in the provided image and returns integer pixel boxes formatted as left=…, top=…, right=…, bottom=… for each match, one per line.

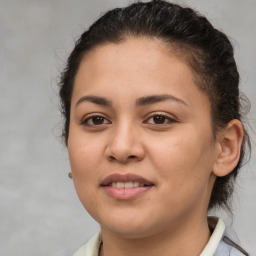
left=73, top=38, right=210, bottom=109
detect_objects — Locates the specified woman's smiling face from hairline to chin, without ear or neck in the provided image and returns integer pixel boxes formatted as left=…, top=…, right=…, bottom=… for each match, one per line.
left=68, top=38, right=217, bottom=237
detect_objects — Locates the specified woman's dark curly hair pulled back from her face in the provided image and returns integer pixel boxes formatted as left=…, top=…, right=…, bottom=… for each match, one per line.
left=59, top=0, right=250, bottom=210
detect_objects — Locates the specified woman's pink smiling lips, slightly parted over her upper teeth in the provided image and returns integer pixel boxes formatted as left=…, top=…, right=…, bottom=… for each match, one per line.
left=101, top=174, right=154, bottom=200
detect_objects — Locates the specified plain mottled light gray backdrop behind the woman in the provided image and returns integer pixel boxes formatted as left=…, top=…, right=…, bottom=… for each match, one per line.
left=0, top=0, right=256, bottom=256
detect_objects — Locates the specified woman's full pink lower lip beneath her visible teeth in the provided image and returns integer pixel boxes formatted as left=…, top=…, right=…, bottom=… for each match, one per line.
left=102, top=186, right=153, bottom=200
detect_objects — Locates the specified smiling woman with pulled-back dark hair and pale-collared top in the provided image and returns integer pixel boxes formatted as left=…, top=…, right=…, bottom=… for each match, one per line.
left=57, top=1, right=249, bottom=256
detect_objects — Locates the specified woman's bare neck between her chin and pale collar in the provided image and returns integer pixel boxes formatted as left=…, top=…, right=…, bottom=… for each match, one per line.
left=100, top=218, right=210, bottom=256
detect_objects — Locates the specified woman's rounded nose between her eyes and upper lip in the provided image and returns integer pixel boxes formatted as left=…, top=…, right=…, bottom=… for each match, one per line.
left=106, top=121, right=145, bottom=163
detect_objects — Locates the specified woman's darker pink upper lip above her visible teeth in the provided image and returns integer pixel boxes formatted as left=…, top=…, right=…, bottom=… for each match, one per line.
left=101, top=173, right=153, bottom=186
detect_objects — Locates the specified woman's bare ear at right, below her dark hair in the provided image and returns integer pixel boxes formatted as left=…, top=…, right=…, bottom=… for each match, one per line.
left=213, top=119, right=243, bottom=177
